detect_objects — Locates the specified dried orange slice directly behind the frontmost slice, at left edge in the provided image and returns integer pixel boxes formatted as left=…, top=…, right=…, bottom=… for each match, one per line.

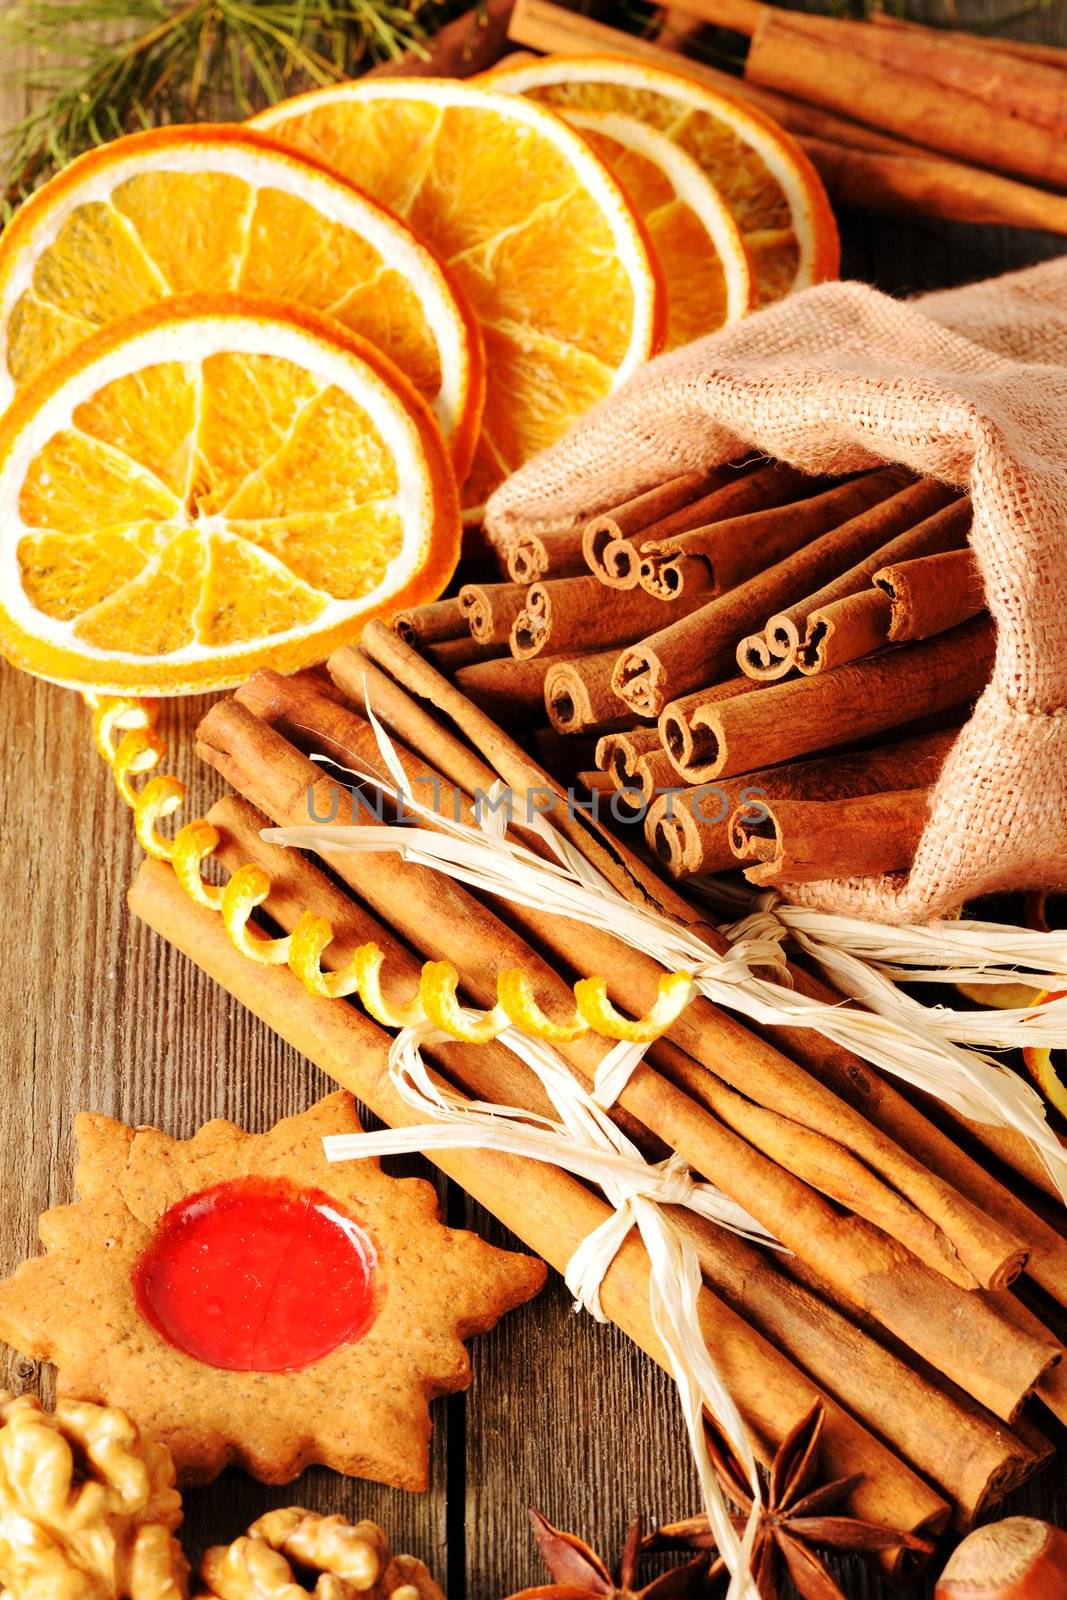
left=0, top=126, right=485, bottom=477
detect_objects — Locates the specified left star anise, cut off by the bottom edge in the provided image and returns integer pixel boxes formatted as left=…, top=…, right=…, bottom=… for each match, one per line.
left=509, top=1510, right=723, bottom=1600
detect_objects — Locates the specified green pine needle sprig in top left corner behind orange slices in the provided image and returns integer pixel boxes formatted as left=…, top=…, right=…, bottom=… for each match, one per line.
left=0, top=0, right=450, bottom=212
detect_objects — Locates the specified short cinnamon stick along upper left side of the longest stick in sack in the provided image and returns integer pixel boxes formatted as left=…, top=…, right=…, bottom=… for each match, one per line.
left=510, top=576, right=701, bottom=661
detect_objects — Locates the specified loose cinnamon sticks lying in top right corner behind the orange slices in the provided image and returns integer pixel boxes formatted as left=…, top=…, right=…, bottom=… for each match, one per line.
left=509, top=0, right=1067, bottom=234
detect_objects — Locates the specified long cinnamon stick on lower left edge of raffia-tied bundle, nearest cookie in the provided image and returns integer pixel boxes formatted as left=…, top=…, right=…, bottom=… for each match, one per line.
left=130, top=861, right=949, bottom=1533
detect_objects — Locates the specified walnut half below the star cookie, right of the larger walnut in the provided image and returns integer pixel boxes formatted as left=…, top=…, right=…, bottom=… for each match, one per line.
left=197, top=1507, right=445, bottom=1600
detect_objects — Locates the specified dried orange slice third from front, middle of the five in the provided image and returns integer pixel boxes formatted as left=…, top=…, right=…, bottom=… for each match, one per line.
left=254, top=78, right=662, bottom=509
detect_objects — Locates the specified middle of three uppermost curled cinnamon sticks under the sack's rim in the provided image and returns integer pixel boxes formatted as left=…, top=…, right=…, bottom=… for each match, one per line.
left=582, top=461, right=819, bottom=589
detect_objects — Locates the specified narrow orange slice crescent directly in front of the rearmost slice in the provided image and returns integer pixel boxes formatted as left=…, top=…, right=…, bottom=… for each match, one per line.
left=566, top=110, right=755, bottom=350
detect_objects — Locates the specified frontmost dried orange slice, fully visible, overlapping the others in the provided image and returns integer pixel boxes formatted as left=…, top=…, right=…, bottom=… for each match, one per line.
left=0, top=296, right=459, bottom=694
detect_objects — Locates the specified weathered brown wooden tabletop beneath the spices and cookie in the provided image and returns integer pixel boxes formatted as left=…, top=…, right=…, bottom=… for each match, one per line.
left=0, top=0, right=1067, bottom=1600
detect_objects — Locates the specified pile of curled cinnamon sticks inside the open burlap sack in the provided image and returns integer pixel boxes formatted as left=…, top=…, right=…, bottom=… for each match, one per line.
left=395, top=459, right=993, bottom=885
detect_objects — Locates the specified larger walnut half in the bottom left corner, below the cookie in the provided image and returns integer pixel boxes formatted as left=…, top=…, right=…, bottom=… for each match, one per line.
left=0, top=1392, right=189, bottom=1600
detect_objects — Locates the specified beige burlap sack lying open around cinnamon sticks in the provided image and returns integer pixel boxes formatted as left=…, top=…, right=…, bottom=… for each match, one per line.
left=488, top=258, right=1067, bottom=922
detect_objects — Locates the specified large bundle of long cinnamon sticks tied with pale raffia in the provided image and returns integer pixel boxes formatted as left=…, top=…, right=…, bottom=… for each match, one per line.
left=131, top=624, right=1067, bottom=1570
